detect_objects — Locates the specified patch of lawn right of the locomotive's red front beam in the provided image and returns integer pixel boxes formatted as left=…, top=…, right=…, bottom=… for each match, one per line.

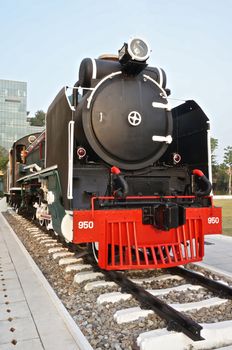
left=214, top=199, right=232, bottom=236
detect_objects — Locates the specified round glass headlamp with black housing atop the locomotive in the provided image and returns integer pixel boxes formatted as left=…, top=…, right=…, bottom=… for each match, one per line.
left=118, top=38, right=150, bottom=75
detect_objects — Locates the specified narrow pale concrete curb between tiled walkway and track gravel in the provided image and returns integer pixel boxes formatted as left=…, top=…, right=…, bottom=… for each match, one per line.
left=0, top=213, right=93, bottom=350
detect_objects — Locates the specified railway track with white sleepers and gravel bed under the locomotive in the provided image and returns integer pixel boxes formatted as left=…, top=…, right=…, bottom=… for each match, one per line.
left=4, top=208, right=232, bottom=350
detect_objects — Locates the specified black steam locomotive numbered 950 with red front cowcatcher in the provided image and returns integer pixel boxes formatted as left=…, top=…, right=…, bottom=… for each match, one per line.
left=8, top=38, right=221, bottom=270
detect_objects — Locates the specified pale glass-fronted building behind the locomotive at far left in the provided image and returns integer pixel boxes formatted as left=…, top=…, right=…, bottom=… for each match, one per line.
left=0, top=79, right=44, bottom=150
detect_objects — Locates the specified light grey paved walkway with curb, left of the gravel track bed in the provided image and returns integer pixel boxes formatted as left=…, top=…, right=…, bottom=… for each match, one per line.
left=0, top=200, right=92, bottom=350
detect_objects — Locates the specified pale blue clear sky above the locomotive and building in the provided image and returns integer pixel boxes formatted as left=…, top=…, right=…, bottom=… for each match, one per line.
left=0, top=0, right=232, bottom=162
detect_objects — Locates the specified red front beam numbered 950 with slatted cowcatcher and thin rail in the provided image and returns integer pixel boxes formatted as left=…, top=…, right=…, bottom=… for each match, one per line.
left=73, top=196, right=222, bottom=270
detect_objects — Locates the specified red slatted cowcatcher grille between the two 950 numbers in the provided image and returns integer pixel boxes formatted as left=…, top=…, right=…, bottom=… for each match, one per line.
left=105, top=219, right=204, bottom=269
